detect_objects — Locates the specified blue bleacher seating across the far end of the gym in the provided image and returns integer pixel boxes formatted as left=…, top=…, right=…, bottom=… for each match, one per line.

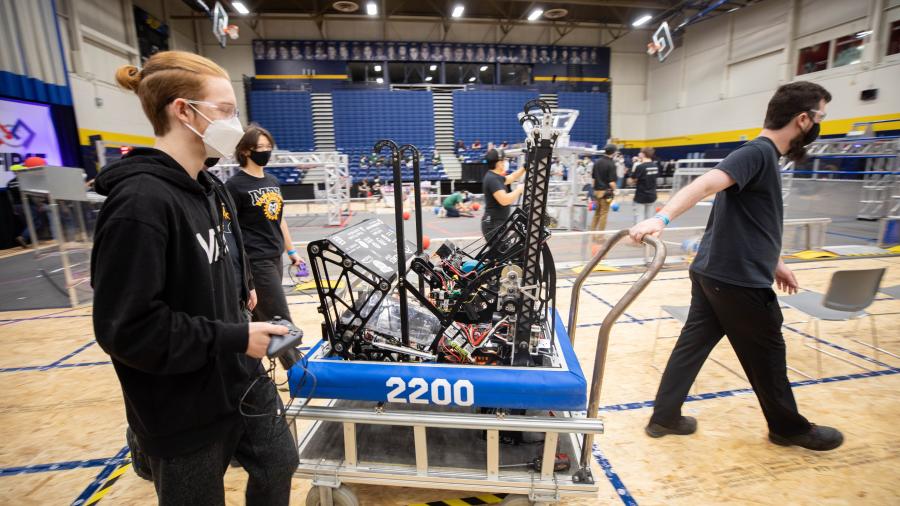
left=244, top=89, right=609, bottom=185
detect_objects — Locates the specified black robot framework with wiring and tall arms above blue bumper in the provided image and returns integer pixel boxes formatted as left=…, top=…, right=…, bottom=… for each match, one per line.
left=307, top=100, right=560, bottom=366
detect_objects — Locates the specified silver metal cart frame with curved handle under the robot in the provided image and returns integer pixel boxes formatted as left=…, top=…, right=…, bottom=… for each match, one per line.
left=285, top=230, right=666, bottom=506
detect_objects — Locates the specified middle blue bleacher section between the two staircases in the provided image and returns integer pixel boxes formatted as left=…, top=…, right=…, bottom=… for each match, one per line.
left=332, top=90, right=451, bottom=181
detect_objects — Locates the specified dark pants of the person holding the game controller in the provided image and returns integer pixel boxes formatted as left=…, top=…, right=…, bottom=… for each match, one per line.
left=149, top=380, right=299, bottom=506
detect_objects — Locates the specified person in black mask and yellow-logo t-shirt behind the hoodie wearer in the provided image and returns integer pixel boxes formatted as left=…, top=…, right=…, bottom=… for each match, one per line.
left=225, top=125, right=302, bottom=321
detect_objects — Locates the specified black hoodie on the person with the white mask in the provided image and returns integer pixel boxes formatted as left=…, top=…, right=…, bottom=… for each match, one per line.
left=91, top=148, right=259, bottom=457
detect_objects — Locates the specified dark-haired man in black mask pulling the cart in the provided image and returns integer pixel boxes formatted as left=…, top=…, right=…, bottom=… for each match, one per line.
left=630, top=81, right=844, bottom=451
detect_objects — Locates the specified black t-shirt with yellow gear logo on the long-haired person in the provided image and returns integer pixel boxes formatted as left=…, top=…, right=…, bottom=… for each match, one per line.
left=225, top=171, right=284, bottom=260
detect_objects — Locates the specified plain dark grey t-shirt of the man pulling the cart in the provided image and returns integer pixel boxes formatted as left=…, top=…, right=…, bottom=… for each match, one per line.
left=691, top=137, right=784, bottom=288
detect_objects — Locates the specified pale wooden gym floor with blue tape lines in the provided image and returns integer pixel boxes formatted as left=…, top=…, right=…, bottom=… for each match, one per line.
left=0, top=257, right=900, bottom=505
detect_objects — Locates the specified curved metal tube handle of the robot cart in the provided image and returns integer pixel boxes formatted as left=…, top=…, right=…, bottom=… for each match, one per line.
left=569, top=230, right=666, bottom=469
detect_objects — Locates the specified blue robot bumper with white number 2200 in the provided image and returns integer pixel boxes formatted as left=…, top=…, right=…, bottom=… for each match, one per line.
left=288, top=313, right=587, bottom=411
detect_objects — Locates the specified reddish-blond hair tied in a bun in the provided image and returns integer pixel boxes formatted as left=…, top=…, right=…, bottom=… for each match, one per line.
left=116, top=51, right=228, bottom=136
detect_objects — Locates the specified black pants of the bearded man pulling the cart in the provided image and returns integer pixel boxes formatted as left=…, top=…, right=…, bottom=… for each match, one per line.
left=651, top=272, right=810, bottom=436
